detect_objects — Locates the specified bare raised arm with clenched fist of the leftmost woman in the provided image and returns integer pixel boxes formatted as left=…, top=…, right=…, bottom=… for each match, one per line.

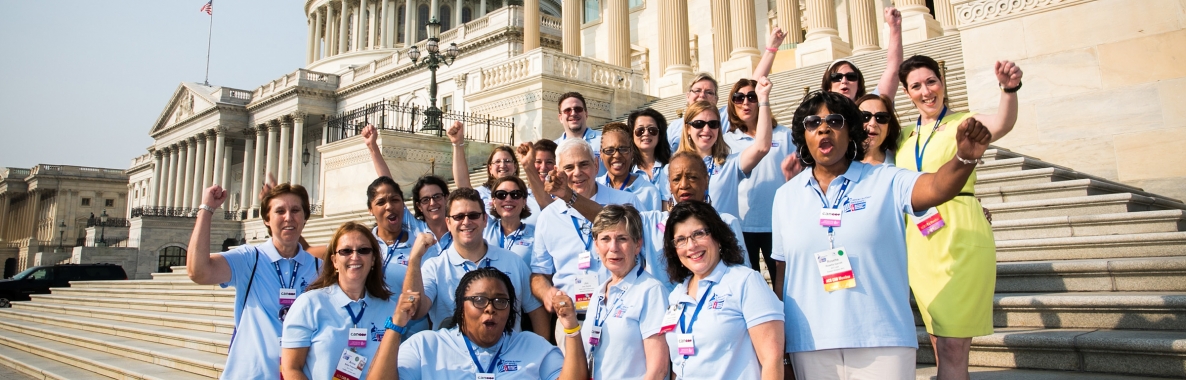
left=185, top=185, right=230, bottom=285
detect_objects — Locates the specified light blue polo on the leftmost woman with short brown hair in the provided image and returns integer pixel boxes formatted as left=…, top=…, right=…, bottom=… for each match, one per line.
left=218, top=239, right=325, bottom=379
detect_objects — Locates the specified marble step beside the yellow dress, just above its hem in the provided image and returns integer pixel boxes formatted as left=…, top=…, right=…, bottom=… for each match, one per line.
left=914, top=292, right=1186, bottom=331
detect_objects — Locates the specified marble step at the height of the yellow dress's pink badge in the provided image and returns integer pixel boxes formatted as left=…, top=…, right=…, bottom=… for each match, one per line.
left=989, top=208, right=1186, bottom=238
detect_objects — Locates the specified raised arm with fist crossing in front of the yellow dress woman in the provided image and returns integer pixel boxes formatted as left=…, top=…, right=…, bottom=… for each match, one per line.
left=911, top=118, right=993, bottom=211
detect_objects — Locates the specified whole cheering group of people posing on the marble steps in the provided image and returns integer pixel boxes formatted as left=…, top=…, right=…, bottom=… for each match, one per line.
left=186, top=8, right=1021, bottom=380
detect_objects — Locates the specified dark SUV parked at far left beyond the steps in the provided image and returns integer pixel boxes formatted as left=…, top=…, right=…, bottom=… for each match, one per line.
left=0, top=264, right=128, bottom=308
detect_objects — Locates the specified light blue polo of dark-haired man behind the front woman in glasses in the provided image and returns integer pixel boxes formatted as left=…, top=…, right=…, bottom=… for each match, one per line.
left=420, top=245, right=542, bottom=331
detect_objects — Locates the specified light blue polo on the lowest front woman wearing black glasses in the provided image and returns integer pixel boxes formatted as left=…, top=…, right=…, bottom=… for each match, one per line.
left=398, top=328, right=565, bottom=380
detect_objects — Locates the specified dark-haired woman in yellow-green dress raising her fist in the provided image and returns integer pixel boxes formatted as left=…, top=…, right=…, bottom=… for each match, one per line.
left=897, top=56, right=1021, bottom=379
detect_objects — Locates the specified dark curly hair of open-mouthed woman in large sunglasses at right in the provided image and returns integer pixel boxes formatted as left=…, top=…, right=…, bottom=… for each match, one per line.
left=791, top=91, right=869, bottom=166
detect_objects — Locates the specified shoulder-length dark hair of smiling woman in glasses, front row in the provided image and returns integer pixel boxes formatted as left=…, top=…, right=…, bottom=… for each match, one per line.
left=663, top=201, right=745, bottom=283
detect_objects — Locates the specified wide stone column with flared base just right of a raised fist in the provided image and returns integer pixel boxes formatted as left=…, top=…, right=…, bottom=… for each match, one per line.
left=795, top=0, right=853, bottom=68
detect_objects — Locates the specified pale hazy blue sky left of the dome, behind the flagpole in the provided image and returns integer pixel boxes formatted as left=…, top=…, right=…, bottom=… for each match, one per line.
left=0, top=0, right=308, bottom=169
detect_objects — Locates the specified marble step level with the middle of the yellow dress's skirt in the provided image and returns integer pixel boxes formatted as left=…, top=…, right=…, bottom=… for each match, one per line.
left=996, top=255, right=1186, bottom=293
